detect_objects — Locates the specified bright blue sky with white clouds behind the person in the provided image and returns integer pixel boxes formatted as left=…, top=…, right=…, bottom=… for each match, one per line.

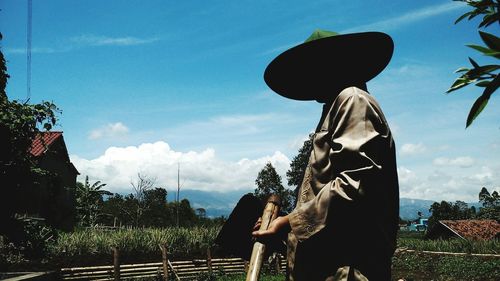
left=0, top=0, right=500, bottom=202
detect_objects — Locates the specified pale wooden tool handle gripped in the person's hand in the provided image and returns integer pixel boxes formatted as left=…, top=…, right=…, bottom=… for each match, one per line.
left=246, top=194, right=281, bottom=281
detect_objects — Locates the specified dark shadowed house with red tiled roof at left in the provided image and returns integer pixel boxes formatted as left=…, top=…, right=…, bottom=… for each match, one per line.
left=23, top=131, right=79, bottom=229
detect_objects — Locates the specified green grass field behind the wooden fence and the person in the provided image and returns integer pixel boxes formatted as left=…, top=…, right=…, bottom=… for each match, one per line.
left=3, top=227, right=500, bottom=281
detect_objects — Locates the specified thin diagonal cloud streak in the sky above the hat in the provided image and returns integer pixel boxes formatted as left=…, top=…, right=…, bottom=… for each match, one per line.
left=341, top=2, right=464, bottom=33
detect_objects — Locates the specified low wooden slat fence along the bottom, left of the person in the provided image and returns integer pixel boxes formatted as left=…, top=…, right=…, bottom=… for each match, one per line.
left=60, top=249, right=286, bottom=281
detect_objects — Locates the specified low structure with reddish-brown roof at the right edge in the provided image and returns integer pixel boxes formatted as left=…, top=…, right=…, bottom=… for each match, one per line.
left=427, top=220, right=500, bottom=240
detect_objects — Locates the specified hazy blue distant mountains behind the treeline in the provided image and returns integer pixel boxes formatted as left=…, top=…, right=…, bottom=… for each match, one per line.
left=167, top=189, right=480, bottom=220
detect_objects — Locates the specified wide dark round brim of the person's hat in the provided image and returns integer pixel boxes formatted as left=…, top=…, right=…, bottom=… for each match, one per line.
left=264, top=32, right=394, bottom=100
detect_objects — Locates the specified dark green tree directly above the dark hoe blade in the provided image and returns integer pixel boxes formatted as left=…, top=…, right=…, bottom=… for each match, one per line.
left=254, top=162, right=293, bottom=213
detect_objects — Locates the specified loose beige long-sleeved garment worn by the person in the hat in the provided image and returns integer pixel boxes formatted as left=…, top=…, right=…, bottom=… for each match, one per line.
left=287, top=87, right=399, bottom=281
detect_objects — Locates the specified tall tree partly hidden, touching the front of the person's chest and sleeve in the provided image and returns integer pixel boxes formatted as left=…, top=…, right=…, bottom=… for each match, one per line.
left=286, top=134, right=314, bottom=205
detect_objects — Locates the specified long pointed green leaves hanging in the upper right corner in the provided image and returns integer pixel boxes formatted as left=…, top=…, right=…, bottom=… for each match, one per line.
left=446, top=0, right=500, bottom=128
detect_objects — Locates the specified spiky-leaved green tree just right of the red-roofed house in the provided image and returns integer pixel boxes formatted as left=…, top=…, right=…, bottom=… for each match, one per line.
left=76, top=176, right=112, bottom=226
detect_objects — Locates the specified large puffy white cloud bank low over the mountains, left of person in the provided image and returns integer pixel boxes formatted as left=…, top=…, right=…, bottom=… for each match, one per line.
left=71, top=141, right=290, bottom=192
